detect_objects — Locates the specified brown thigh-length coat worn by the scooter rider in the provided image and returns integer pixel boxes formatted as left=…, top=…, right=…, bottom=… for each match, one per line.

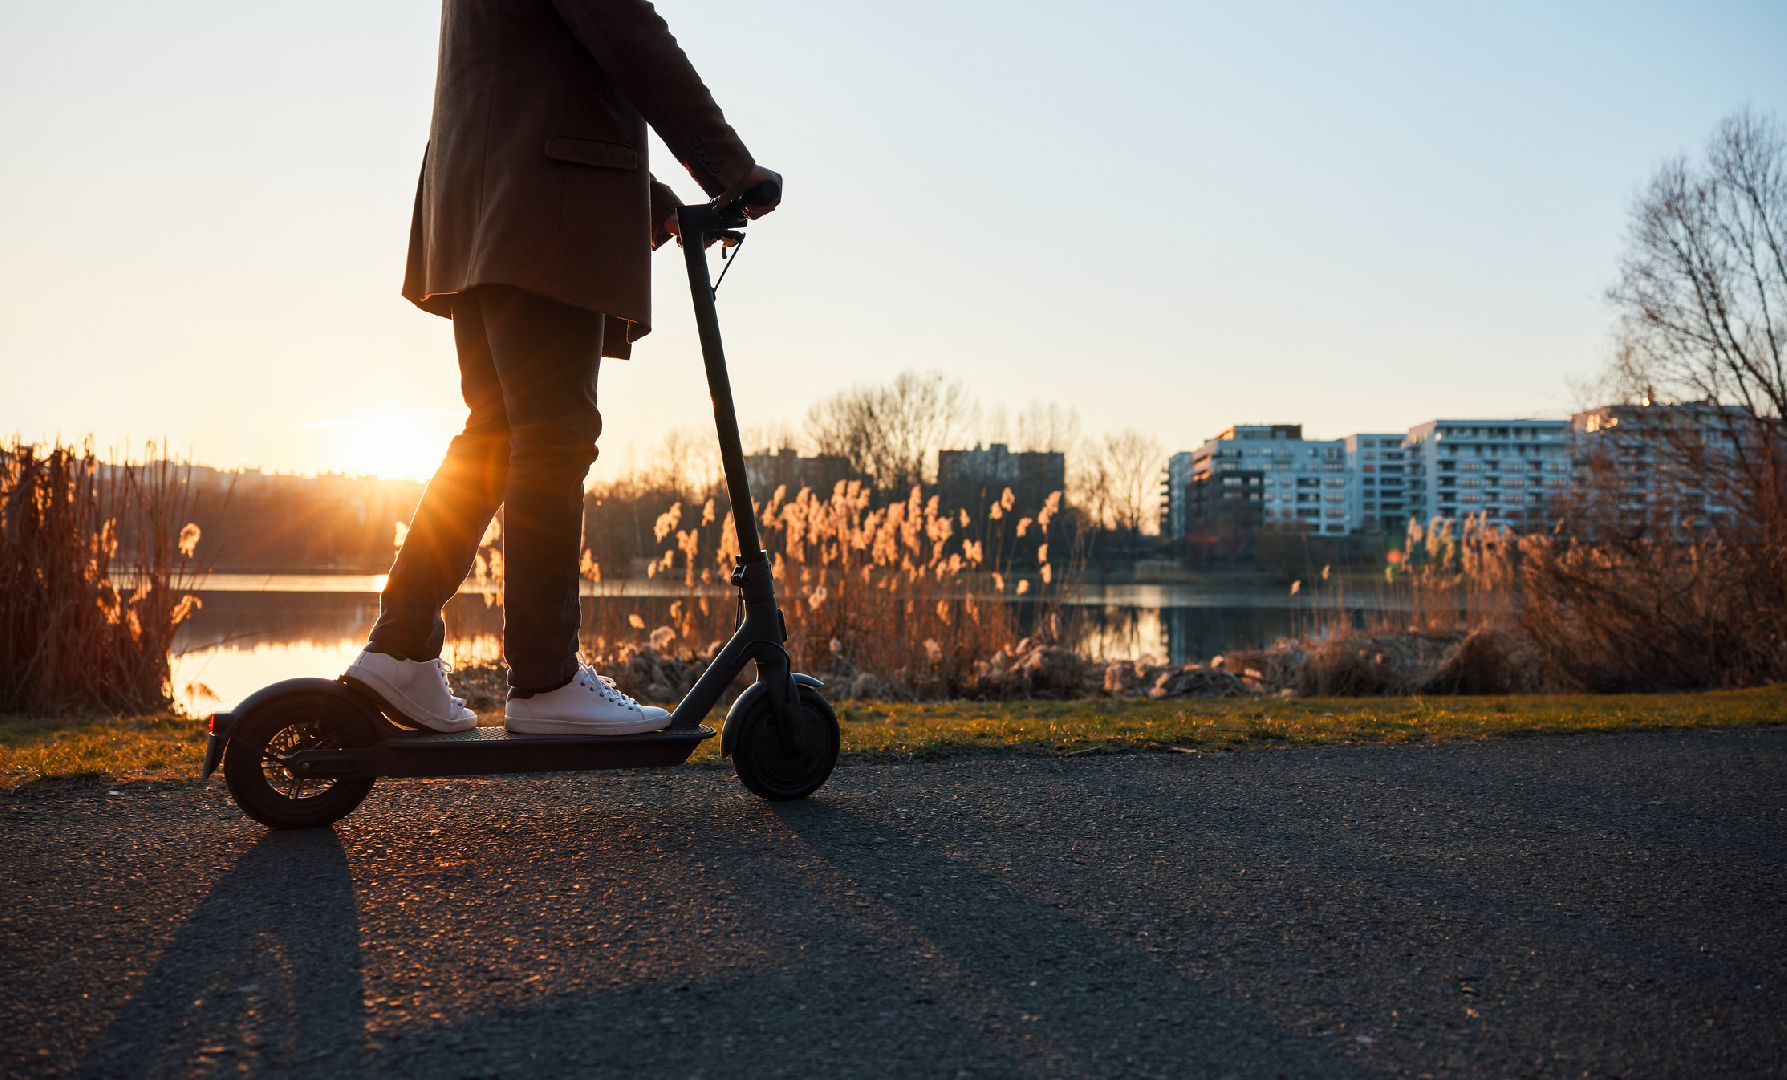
left=404, top=0, right=754, bottom=358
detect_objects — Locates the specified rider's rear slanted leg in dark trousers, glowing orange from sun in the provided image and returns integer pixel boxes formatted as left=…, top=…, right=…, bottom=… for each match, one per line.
left=368, top=290, right=509, bottom=660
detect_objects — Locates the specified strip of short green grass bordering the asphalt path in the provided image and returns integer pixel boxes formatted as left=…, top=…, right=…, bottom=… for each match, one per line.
left=0, top=687, right=1787, bottom=790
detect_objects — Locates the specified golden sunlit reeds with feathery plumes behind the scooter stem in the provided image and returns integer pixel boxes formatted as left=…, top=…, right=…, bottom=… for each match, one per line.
left=584, top=481, right=1083, bottom=699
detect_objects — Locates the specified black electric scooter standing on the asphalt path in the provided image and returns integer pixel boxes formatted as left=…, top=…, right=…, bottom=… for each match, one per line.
left=204, top=182, right=840, bottom=830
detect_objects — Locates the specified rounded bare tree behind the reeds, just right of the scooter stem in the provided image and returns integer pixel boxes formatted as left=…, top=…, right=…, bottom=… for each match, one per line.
left=806, top=370, right=979, bottom=492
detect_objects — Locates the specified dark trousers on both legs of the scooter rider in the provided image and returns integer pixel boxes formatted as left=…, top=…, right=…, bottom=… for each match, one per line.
left=370, top=284, right=602, bottom=690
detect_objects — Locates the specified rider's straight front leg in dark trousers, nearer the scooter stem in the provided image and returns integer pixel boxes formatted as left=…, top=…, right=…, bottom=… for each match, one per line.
left=479, top=286, right=602, bottom=692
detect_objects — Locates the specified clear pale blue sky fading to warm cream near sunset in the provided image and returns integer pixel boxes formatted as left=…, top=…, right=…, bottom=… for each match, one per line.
left=0, top=0, right=1787, bottom=477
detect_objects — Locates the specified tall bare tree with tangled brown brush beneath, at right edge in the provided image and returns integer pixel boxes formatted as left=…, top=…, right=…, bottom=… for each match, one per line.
left=1521, top=109, right=1787, bottom=690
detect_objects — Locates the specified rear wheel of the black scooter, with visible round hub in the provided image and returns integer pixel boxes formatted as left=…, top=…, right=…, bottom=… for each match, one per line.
left=223, top=694, right=377, bottom=830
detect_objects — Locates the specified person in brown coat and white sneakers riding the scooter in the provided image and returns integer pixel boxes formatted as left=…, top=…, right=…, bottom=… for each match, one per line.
left=343, top=0, right=781, bottom=735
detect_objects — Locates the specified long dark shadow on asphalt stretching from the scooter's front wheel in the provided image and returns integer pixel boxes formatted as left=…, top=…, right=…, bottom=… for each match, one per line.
left=774, top=799, right=1363, bottom=1078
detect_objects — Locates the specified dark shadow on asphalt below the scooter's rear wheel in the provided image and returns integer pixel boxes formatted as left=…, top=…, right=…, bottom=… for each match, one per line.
left=80, top=830, right=366, bottom=1080
